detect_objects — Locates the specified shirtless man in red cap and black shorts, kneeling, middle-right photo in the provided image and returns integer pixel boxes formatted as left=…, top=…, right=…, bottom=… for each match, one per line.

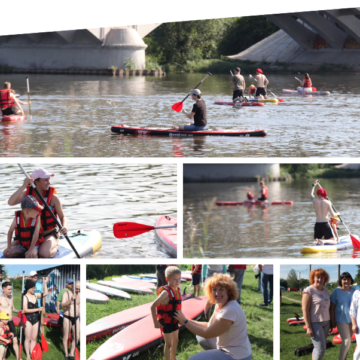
left=310, top=180, right=340, bottom=245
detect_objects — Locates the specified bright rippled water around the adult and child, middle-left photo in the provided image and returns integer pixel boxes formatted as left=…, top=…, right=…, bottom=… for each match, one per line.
left=0, top=163, right=177, bottom=259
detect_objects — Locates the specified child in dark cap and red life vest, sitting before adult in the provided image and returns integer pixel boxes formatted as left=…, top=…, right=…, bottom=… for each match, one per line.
left=4, top=195, right=44, bottom=258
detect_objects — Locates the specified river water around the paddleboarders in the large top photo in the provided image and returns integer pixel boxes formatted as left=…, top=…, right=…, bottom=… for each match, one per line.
left=0, top=74, right=360, bottom=157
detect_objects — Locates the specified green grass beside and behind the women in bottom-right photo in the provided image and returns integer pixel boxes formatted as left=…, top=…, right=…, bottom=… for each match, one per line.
left=280, top=292, right=356, bottom=360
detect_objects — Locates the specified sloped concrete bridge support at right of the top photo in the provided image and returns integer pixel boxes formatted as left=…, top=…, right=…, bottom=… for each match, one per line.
left=230, top=8, right=360, bottom=71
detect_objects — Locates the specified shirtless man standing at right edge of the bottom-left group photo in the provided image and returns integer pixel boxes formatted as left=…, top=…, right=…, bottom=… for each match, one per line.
left=61, top=281, right=80, bottom=360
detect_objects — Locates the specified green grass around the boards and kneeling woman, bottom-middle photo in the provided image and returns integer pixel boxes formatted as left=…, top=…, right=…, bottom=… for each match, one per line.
left=86, top=268, right=273, bottom=360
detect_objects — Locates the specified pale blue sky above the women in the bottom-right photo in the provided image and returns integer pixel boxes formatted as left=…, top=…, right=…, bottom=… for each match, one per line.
left=280, top=264, right=358, bottom=282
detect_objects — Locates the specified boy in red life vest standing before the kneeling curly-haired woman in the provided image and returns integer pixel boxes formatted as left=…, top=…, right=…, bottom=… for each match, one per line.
left=151, top=266, right=181, bottom=360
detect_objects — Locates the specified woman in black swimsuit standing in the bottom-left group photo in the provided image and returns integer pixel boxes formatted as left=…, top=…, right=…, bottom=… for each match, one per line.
left=23, top=279, right=48, bottom=360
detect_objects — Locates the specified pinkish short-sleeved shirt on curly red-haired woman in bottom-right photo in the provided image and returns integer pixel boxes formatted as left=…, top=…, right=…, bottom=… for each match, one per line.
left=303, top=285, right=330, bottom=322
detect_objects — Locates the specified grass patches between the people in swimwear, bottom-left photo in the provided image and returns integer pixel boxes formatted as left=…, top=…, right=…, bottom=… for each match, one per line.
left=6, top=290, right=74, bottom=360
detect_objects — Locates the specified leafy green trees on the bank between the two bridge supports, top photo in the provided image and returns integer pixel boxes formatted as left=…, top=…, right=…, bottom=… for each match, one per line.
left=144, top=16, right=279, bottom=74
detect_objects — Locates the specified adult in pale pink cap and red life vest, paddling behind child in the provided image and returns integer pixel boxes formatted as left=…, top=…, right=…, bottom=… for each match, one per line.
left=8, top=168, right=67, bottom=258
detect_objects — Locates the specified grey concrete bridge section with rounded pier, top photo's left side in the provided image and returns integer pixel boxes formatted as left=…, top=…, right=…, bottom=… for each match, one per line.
left=0, top=24, right=160, bottom=70
